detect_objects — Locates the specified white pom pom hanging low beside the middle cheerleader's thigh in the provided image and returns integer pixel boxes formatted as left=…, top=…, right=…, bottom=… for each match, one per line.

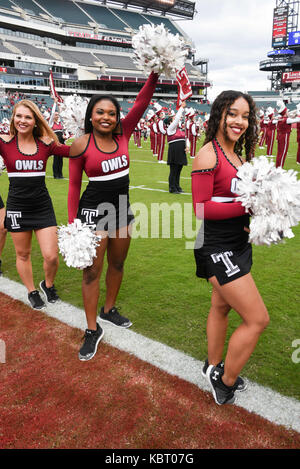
left=58, top=218, right=101, bottom=269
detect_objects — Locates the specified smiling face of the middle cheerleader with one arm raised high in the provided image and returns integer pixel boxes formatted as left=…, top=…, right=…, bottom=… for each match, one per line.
left=91, top=99, right=118, bottom=135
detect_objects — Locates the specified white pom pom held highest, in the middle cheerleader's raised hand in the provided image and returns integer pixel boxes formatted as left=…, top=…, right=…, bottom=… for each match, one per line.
left=132, top=24, right=187, bottom=78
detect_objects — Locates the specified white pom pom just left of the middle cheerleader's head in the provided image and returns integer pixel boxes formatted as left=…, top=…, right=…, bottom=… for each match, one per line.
left=59, top=94, right=88, bottom=138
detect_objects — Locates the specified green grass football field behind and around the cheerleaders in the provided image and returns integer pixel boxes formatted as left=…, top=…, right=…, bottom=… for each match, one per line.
left=0, top=130, right=300, bottom=399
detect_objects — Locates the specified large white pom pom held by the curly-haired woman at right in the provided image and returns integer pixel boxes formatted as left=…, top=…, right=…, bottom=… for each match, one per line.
left=236, top=156, right=300, bottom=245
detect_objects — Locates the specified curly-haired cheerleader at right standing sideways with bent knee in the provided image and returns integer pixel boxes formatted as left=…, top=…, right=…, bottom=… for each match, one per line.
left=192, top=91, right=269, bottom=405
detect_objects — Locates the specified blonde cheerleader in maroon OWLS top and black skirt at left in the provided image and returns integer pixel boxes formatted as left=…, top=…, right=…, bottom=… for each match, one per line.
left=0, top=100, right=70, bottom=309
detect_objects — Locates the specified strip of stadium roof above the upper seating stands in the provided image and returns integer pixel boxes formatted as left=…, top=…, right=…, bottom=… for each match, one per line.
left=86, top=0, right=195, bottom=19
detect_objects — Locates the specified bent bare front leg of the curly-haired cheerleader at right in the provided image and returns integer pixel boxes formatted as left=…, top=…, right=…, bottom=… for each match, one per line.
left=209, top=273, right=269, bottom=386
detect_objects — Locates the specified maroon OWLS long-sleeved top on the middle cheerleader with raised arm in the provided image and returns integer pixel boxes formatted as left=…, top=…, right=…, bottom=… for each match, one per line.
left=68, top=72, right=158, bottom=223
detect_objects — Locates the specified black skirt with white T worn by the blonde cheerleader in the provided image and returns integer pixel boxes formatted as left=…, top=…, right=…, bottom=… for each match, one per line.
left=5, top=177, right=57, bottom=233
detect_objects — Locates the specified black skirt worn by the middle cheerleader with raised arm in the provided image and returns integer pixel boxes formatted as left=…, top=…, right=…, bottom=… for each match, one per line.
left=77, top=177, right=134, bottom=233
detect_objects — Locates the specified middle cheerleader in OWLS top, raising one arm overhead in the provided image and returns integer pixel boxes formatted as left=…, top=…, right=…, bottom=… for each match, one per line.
left=68, top=73, right=158, bottom=361
